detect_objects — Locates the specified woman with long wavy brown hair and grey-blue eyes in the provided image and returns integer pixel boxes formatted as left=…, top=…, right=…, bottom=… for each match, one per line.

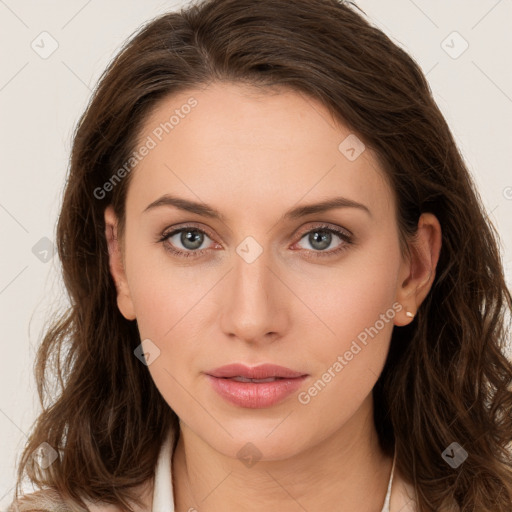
left=8, top=0, right=512, bottom=512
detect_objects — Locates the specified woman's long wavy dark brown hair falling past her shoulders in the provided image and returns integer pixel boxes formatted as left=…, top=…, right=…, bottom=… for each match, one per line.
left=11, top=0, right=512, bottom=512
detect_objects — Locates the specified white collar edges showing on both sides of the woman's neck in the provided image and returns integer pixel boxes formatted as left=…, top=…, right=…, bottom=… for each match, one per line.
left=151, top=429, right=396, bottom=512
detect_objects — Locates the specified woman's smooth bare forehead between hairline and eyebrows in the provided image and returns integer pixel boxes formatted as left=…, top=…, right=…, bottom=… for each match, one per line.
left=128, top=83, right=392, bottom=221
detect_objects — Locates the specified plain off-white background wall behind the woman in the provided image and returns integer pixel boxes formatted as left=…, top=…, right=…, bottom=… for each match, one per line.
left=0, top=0, right=512, bottom=504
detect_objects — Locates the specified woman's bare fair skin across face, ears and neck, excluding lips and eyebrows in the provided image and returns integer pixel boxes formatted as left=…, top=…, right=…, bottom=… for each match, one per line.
left=105, top=83, right=441, bottom=512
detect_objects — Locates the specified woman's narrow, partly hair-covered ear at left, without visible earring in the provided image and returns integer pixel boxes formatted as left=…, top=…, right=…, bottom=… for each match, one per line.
left=105, top=205, right=136, bottom=320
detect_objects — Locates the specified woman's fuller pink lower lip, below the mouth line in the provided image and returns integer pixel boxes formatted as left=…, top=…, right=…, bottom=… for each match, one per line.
left=207, top=375, right=307, bottom=409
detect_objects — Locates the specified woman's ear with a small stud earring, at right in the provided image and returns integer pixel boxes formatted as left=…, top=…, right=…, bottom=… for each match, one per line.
left=394, top=213, right=442, bottom=325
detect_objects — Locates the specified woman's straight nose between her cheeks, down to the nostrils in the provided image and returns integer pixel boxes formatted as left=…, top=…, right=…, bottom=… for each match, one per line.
left=220, top=246, right=292, bottom=344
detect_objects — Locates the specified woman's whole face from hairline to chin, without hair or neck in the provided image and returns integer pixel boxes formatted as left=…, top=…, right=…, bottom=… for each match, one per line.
left=106, top=84, right=416, bottom=459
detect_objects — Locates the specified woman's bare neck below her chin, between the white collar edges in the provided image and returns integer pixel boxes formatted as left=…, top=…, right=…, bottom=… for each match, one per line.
left=172, top=394, right=392, bottom=512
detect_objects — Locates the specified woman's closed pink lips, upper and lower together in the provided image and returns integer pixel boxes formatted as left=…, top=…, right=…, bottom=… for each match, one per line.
left=206, top=364, right=308, bottom=409
